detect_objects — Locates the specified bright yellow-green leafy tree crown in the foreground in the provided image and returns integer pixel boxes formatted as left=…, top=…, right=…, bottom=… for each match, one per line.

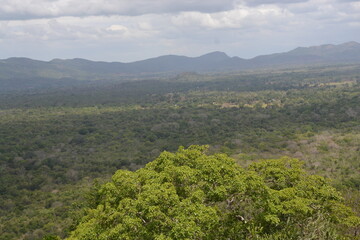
left=69, top=146, right=359, bottom=240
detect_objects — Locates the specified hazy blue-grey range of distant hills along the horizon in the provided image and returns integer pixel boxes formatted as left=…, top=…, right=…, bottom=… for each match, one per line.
left=0, top=42, right=360, bottom=91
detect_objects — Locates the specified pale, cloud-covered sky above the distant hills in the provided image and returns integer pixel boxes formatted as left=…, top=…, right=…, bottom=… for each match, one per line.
left=0, top=0, right=360, bottom=62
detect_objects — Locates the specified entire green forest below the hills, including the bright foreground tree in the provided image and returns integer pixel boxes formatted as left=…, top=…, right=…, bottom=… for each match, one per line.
left=0, top=65, right=360, bottom=240
